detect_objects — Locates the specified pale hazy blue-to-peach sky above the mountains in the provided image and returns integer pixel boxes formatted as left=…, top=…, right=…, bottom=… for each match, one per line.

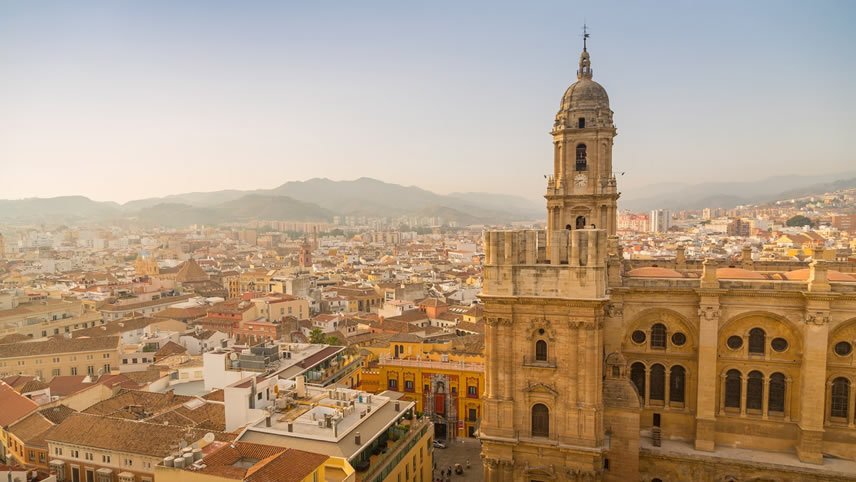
left=0, top=0, right=856, bottom=202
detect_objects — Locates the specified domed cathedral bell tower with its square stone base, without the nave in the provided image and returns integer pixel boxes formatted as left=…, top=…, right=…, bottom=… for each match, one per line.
left=479, top=35, right=618, bottom=482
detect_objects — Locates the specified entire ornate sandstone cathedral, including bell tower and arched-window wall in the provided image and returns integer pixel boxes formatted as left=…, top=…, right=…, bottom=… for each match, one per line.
left=480, top=39, right=856, bottom=482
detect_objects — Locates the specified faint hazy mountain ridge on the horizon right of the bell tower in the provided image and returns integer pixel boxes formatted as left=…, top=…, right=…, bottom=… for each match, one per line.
left=618, top=171, right=856, bottom=211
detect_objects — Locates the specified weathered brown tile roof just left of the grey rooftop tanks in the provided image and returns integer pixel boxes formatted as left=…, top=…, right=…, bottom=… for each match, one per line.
left=45, top=413, right=233, bottom=457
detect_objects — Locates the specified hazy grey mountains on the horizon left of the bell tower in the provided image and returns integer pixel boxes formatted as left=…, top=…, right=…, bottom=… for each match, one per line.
left=0, top=178, right=544, bottom=226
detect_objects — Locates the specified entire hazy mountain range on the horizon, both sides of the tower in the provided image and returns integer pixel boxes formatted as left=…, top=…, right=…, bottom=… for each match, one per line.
left=0, top=171, right=856, bottom=226
